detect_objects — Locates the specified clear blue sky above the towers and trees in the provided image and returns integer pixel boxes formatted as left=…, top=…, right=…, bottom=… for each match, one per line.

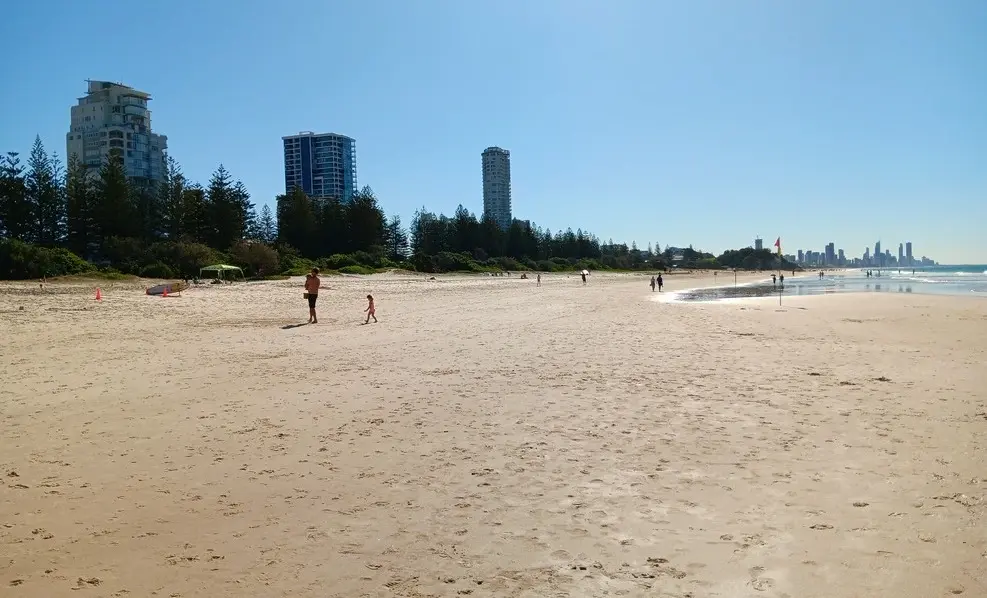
left=0, top=0, right=987, bottom=263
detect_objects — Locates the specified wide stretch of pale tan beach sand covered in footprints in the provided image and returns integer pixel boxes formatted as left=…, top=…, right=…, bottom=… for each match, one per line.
left=0, top=275, right=987, bottom=598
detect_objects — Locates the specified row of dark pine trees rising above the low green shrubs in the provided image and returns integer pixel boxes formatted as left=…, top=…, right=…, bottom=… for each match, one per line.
left=0, top=138, right=711, bottom=276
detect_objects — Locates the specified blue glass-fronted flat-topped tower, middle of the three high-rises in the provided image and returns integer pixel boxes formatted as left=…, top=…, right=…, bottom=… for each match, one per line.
left=281, top=131, right=356, bottom=203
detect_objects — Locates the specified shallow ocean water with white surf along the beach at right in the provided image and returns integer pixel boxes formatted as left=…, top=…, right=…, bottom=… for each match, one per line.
left=674, top=265, right=987, bottom=301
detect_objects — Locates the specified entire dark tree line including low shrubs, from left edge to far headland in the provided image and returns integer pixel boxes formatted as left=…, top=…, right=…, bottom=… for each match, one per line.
left=0, top=138, right=792, bottom=278
